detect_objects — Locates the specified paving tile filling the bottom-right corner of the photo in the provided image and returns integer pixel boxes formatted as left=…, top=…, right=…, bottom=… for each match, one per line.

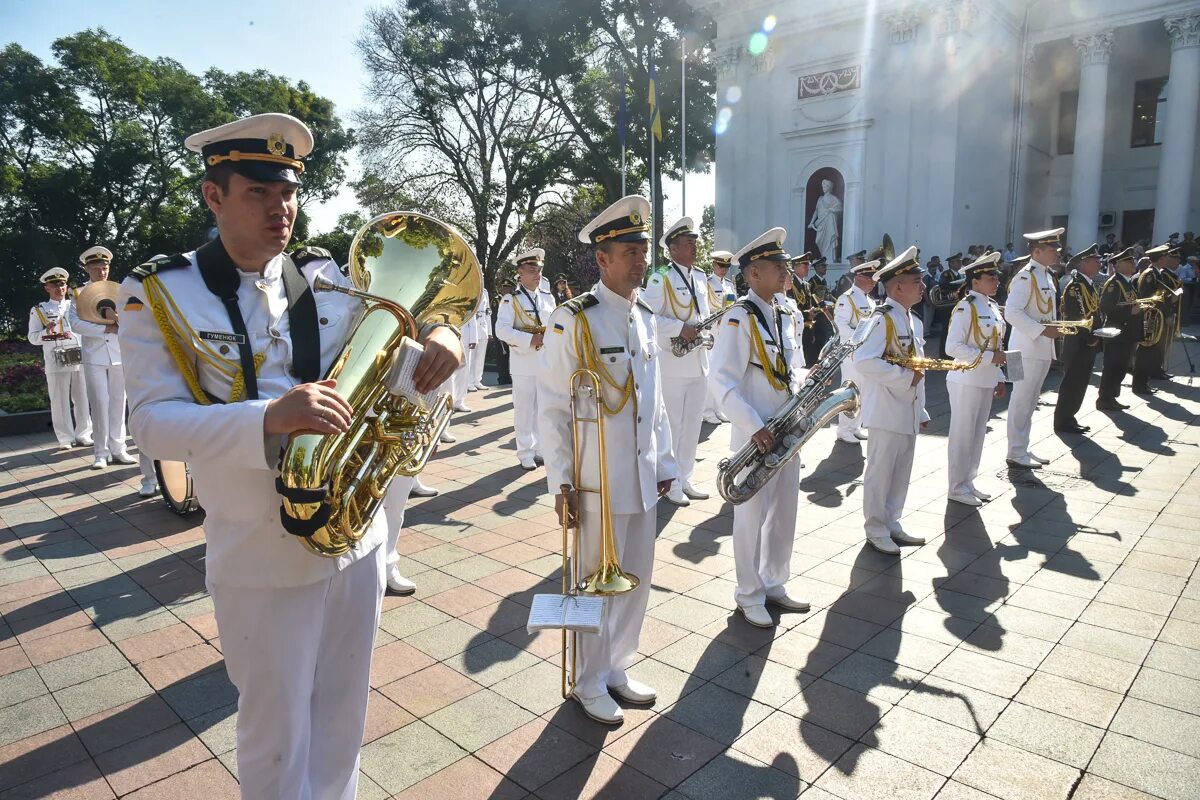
left=1087, top=732, right=1200, bottom=800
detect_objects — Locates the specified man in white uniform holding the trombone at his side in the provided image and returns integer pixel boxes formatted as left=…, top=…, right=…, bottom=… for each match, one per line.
left=540, top=196, right=678, bottom=724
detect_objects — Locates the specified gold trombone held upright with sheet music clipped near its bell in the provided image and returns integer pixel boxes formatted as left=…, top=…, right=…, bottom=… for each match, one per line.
left=560, top=368, right=641, bottom=699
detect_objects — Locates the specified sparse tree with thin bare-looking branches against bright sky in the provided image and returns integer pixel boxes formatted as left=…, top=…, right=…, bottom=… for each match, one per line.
left=358, top=0, right=572, bottom=296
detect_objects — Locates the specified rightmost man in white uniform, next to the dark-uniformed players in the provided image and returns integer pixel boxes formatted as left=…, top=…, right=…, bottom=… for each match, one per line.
left=1004, top=228, right=1066, bottom=469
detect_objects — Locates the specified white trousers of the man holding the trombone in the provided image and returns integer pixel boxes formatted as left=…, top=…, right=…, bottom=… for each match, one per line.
left=575, top=507, right=656, bottom=698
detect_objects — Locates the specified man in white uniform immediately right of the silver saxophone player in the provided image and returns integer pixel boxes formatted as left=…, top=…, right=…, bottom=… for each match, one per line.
left=854, top=247, right=929, bottom=555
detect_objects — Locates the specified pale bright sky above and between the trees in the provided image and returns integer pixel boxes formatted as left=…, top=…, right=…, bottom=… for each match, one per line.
left=0, top=0, right=715, bottom=231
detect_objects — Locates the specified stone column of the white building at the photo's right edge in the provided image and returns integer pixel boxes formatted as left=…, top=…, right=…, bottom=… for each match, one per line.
left=1154, top=14, right=1200, bottom=243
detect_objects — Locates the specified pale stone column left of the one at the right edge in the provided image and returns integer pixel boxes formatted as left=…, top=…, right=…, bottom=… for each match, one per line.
left=1067, top=31, right=1112, bottom=253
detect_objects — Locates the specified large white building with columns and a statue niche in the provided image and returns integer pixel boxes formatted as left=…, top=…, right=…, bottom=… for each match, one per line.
left=694, top=0, right=1200, bottom=271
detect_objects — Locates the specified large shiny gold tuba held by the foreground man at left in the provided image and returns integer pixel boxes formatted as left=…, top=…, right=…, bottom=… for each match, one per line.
left=276, top=211, right=482, bottom=558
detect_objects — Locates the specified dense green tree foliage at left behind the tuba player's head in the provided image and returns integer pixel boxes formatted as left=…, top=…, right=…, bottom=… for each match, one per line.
left=0, top=29, right=352, bottom=326
